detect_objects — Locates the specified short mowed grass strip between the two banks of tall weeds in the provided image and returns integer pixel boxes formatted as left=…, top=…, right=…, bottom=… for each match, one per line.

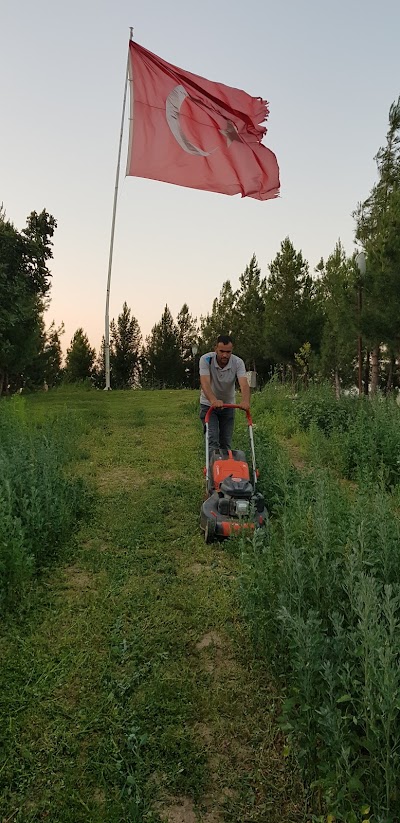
left=0, top=391, right=303, bottom=823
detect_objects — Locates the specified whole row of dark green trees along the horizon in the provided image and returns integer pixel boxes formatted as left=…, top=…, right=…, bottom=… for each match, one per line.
left=0, top=98, right=400, bottom=394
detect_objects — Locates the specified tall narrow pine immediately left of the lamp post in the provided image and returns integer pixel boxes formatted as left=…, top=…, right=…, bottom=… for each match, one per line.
left=317, top=240, right=357, bottom=396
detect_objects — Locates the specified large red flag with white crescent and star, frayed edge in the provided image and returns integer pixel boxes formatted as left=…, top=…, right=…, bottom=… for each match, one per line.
left=127, top=41, right=279, bottom=200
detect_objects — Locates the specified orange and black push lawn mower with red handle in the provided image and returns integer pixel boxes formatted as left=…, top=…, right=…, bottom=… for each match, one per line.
left=200, top=403, right=267, bottom=543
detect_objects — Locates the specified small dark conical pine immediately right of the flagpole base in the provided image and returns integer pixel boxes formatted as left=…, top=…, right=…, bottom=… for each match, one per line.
left=110, top=302, right=142, bottom=389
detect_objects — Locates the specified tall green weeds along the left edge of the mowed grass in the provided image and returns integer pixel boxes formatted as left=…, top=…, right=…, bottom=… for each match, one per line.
left=0, top=397, right=87, bottom=611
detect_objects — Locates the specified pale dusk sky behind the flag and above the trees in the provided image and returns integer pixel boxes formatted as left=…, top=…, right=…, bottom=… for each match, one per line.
left=0, top=0, right=400, bottom=350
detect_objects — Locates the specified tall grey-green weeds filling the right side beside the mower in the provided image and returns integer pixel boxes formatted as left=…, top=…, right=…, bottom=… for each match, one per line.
left=241, top=390, right=400, bottom=823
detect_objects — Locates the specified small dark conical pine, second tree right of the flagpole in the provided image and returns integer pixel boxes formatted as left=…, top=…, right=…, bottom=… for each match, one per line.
left=142, top=306, right=182, bottom=388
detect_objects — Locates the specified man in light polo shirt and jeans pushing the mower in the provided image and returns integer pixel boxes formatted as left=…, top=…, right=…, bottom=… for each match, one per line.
left=199, top=334, right=250, bottom=454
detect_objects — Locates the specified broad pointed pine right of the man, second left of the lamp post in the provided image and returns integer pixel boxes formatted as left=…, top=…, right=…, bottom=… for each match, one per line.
left=265, top=237, right=322, bottom=382
